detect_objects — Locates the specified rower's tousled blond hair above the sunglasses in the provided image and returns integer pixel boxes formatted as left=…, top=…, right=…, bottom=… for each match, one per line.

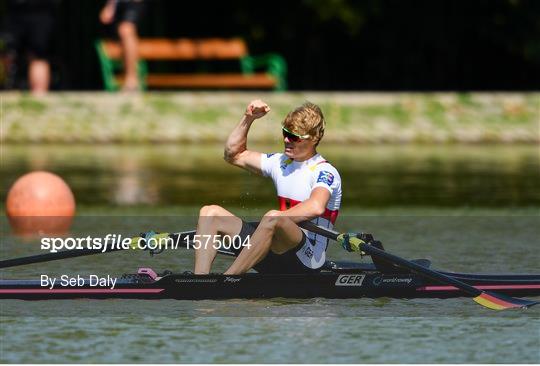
left=283, top=102, right=326, bottom=144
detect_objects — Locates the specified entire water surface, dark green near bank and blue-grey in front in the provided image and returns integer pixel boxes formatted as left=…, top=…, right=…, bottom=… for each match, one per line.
left=0, top=146, right=540, bottom=363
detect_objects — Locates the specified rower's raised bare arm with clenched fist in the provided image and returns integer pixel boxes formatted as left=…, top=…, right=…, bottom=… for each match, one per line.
left=224, top=100, right=270, bottom=174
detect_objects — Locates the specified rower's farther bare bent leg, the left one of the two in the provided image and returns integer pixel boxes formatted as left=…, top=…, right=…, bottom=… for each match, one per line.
left=195, top=205, right=242, bottom=274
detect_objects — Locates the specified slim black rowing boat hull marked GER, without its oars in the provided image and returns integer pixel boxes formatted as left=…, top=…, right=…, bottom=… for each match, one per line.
left=0, top=260, right=540, bottom=300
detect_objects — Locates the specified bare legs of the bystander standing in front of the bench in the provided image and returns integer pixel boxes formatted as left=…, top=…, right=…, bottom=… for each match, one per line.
left=118, top=21, right=139, bottom=91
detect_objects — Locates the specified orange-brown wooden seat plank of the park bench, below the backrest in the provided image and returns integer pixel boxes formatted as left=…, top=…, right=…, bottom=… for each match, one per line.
left=117, top=73, right=277, bottom=89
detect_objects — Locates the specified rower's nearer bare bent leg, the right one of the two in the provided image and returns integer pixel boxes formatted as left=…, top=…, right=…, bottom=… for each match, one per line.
left=225, top=211, right=303, bottom=275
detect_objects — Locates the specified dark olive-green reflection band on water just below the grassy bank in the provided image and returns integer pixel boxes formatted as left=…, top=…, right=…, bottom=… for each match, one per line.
left=0, top=145, right=540, bottom=208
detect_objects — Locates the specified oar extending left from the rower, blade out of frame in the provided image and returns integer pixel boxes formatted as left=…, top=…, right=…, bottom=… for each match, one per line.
left=0, top=230, right=200, bottom=268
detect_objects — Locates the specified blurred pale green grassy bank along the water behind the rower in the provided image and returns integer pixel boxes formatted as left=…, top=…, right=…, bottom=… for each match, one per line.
left=0, top=92, right=540, bottom=143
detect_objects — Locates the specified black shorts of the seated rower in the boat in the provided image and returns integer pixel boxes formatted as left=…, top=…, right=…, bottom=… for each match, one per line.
left=233, top=221, right=320, bottom=274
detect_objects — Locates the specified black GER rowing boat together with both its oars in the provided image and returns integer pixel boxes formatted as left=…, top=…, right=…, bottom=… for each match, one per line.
left=0, top=221, right=540, bottom=310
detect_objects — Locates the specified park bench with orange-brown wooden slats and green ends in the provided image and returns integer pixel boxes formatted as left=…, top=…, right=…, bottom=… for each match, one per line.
left=95, top=38, right=287, bottom=91
